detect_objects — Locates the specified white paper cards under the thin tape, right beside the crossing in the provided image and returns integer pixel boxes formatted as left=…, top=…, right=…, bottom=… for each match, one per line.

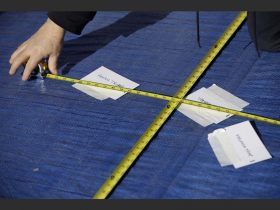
left=178, top=84, right=249, bottom=127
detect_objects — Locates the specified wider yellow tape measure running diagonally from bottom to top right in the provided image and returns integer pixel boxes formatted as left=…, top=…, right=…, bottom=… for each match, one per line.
left=93, top=12, right=247, bottom=199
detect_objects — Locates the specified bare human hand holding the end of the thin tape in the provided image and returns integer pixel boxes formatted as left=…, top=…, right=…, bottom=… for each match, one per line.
left=9, top=18, right=65, bottom=80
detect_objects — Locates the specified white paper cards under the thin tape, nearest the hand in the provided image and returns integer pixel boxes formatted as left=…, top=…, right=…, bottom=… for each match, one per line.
left=72, top=66, right=139, bottom=100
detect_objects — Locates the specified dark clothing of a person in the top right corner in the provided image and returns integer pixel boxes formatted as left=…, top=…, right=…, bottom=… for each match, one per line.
left=247, top=12, right=280, bottom=52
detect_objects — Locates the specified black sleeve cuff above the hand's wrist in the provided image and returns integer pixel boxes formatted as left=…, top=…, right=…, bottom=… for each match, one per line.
left=48, top=11, right=96, bottom=35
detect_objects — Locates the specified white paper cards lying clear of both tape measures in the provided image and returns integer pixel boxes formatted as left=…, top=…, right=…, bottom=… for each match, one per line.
left=208, top=121, right=272, bottom=168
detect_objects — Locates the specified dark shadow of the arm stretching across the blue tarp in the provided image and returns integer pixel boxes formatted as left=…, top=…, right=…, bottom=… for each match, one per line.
left=59, top=12, right=169, bottom=75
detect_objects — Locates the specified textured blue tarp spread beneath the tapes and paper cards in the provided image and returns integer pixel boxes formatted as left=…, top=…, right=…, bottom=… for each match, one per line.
left=0, top=12, right=280, bottom=199
